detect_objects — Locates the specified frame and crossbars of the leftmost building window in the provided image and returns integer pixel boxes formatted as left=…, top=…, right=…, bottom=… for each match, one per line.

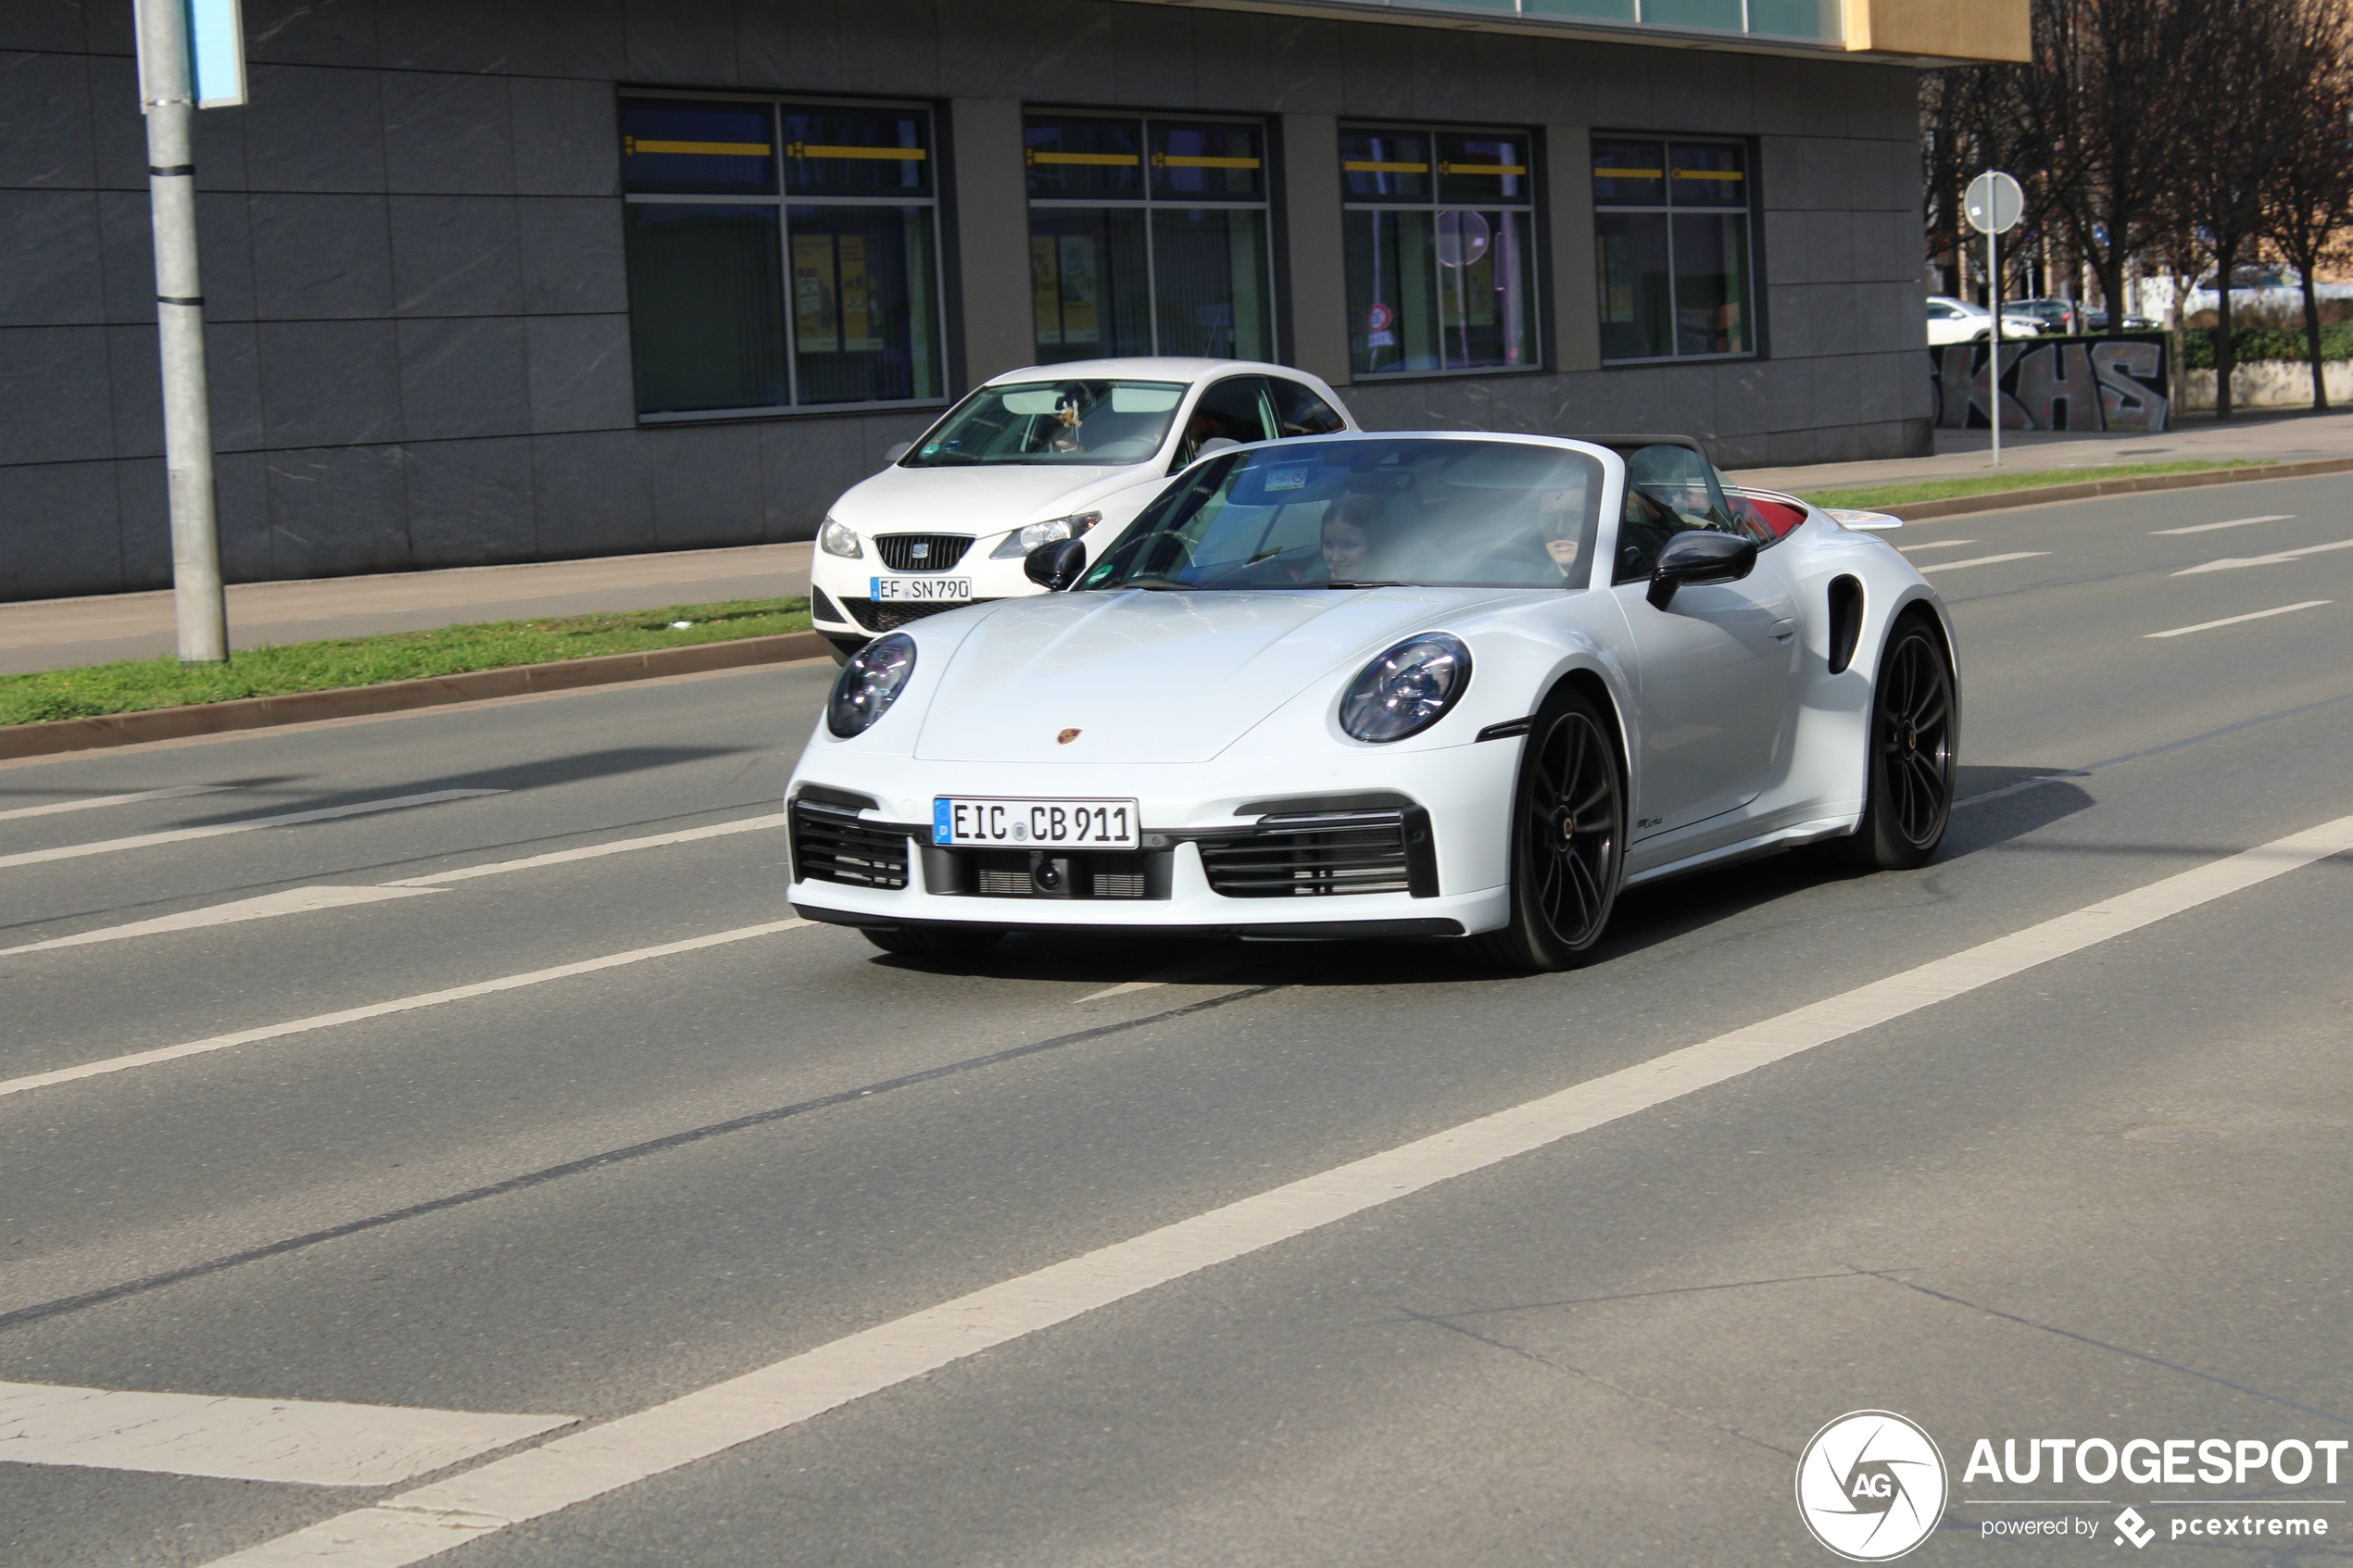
left=614, top=87, right=955, bottom=425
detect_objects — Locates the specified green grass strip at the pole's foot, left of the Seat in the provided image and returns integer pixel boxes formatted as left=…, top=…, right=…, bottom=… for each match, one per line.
left=0, top=599, right=810, bottom=724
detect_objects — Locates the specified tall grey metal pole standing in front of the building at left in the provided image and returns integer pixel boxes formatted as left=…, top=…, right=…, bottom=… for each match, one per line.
left=134, top=0, right=228, bottom=665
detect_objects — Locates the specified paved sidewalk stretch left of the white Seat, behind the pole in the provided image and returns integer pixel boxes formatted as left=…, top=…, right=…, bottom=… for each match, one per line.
left=0, top=543, right=810, bottom=674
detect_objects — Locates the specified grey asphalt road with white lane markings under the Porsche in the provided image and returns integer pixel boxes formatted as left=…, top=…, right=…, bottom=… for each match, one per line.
left=0, top=480, right=2353, bottom=1568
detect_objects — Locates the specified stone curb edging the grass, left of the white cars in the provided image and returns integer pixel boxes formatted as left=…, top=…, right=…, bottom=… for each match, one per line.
left=0, top=633, right=833, bottom=759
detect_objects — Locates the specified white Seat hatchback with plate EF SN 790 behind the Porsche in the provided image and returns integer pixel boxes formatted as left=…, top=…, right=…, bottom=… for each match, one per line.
left=810, top=359, right=1358, bottom=654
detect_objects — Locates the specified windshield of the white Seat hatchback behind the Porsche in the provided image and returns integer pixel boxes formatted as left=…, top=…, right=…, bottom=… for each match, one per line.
left=901, top=381, right=1186, bottom=468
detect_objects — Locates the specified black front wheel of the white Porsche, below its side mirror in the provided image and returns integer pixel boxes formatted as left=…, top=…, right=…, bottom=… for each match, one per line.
left=1471, top=689, right=1626, bottom=971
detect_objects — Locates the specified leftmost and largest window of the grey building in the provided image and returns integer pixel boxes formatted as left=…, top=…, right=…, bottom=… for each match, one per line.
left=622, top=99, right=946, bottom=419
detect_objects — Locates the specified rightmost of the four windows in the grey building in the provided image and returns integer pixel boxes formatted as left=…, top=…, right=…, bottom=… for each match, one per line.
left=1593, top=136, right=1755, bottom=359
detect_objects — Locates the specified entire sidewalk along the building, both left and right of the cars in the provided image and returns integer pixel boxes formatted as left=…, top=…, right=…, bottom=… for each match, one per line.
left=0, top=411, right=2353, bottom=674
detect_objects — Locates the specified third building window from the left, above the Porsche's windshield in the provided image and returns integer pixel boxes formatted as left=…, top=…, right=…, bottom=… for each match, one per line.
left=1339, top=125, right=1541, bottom=376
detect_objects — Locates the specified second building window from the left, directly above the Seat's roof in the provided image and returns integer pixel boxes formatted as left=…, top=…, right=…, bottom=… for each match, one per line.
left=1024, top=115, right=1276, bottom=364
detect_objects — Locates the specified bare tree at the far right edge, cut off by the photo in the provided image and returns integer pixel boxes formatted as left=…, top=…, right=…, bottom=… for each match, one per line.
left=2263, top=0, right=2353, bottom=409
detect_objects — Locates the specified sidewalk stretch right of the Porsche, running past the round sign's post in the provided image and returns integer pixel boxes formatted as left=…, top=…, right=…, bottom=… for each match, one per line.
left=1730, top=409, right=2353, bottom=491
